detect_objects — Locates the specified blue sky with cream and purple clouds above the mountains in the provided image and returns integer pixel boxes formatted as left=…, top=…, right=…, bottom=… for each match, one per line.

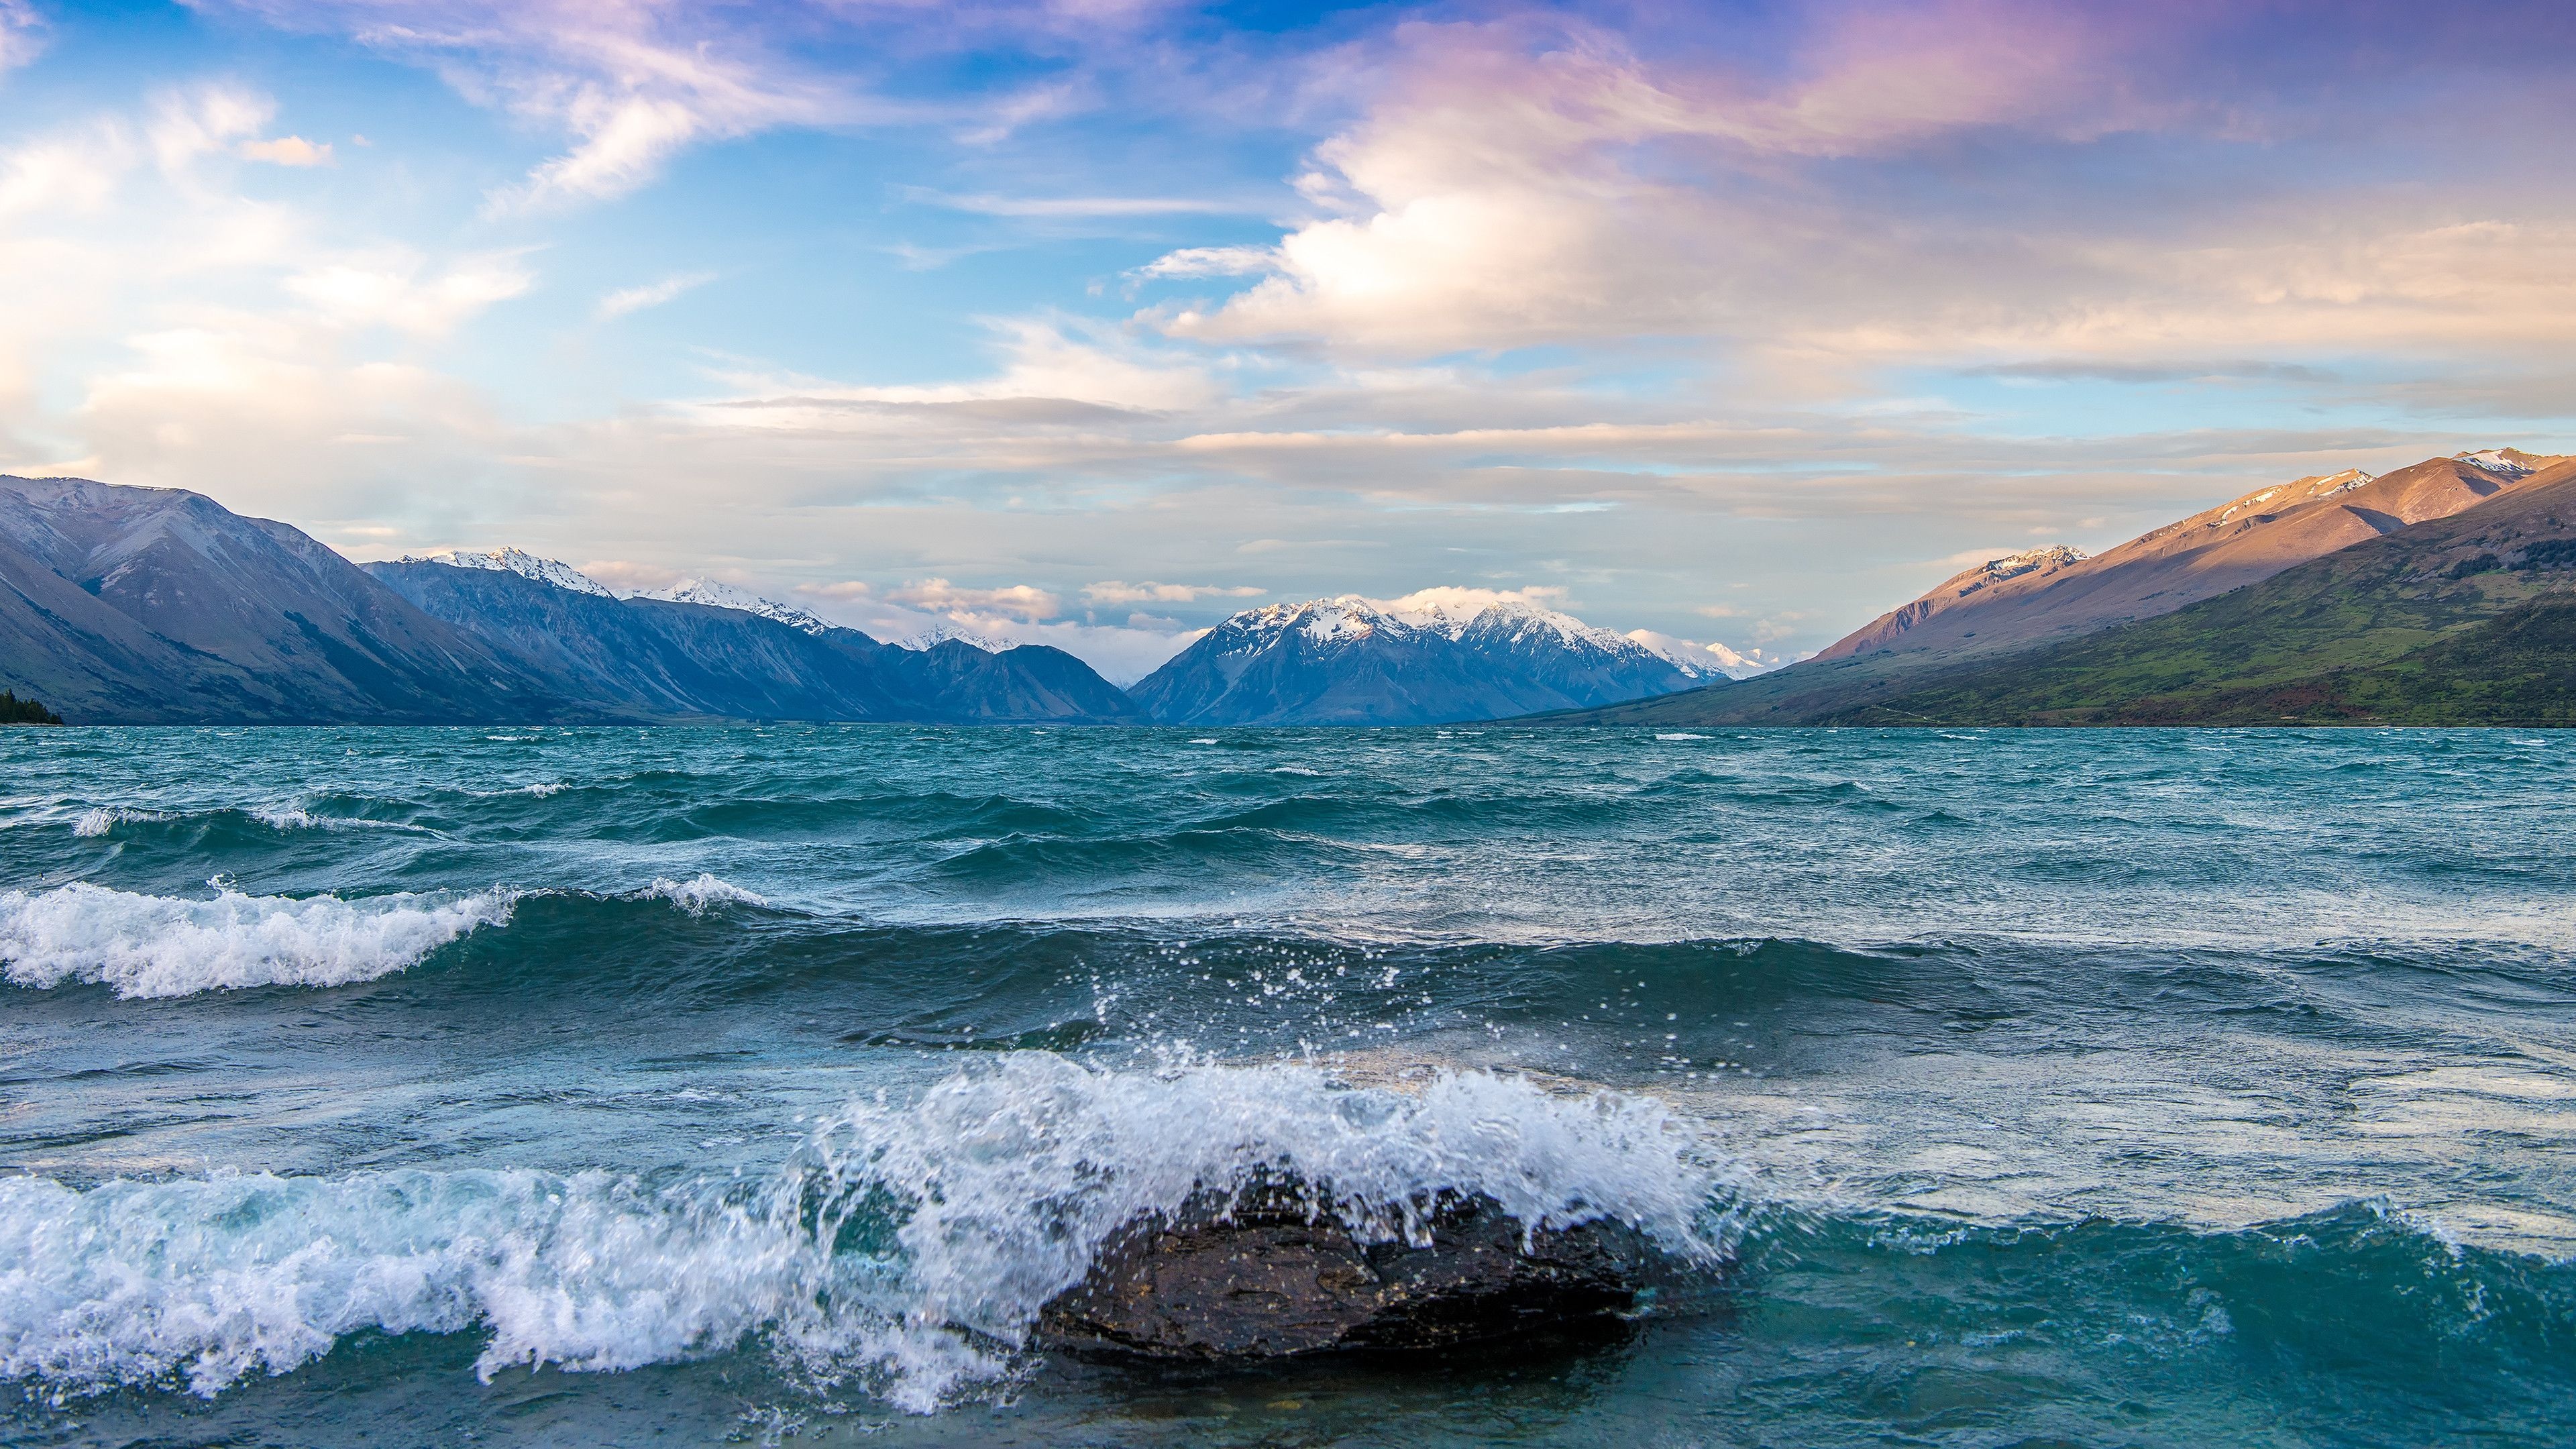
left=0, top=0, right=2576, bottom=678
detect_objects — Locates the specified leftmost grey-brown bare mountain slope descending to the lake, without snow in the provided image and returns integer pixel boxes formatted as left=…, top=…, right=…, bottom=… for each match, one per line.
left=0, top=477, right=580, bottom=724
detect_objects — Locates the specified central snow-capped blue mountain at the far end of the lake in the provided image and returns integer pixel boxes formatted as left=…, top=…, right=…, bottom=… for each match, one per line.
left=1128, top=588, right=1708, bottom=724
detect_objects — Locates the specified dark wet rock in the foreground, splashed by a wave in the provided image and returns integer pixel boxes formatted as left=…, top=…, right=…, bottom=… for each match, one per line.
left=1038, top=1183, right=1654, bottom=1361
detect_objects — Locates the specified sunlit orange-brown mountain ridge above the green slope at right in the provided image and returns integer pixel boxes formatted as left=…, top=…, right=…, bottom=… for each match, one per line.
left=1816, top=449, right=2576, bottom=660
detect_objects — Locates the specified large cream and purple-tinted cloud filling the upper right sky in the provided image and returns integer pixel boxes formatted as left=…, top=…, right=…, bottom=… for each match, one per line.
left=1131, top=0, right=2576, bottom=371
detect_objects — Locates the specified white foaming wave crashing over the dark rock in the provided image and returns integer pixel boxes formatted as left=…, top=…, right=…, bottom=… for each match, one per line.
left=0, top=1052, right=1733, bottom=1413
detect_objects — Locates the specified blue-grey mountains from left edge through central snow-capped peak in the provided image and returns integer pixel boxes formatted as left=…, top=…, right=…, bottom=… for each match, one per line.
left=0, top=477, right=1718, bottom=724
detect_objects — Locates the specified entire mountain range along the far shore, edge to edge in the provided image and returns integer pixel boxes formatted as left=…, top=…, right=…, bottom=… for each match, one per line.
left=0, top=449, right=2576, bottom=727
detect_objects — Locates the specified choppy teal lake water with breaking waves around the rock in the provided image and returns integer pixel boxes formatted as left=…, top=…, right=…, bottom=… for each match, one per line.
left=0, top=727, right=2576, bottom=1444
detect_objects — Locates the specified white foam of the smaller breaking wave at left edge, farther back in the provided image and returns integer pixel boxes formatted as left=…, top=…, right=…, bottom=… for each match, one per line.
left=0, top=881, right=518, bottom=998
